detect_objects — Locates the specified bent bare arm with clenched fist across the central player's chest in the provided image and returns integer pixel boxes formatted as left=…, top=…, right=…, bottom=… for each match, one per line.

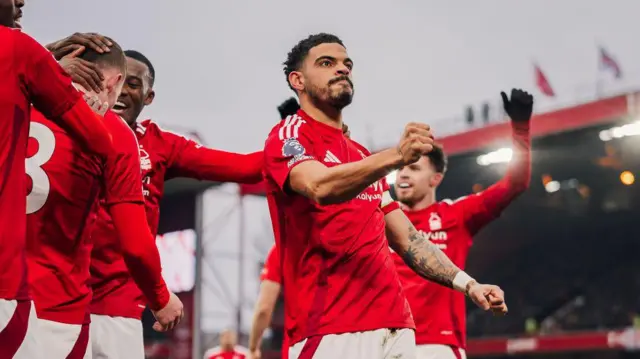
left=288, top=123, right=433, bottom=205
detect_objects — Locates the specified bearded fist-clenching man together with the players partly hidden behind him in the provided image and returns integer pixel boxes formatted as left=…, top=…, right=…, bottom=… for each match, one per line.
left=249, top=34, right=533, bottom=359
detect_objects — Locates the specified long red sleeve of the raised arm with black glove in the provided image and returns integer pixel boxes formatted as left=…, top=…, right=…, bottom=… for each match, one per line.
left=454, top=123, right=531, bottom=234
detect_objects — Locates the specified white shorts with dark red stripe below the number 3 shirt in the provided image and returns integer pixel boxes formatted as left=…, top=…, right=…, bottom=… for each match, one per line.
left=38, top=319, right=91, bottom=359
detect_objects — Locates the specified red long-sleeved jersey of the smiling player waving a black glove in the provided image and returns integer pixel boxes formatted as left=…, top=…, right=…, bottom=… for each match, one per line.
left=393, top=125, right=531, bottom=348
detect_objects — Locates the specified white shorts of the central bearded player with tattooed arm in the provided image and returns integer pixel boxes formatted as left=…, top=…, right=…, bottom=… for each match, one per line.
left=289, top=329, right=416, bottom=359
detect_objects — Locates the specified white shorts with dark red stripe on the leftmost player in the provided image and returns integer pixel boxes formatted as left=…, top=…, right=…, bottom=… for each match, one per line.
left=0, top=299, right=43, bottom=359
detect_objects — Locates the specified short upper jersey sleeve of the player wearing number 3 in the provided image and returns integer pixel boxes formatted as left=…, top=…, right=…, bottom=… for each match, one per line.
left=104, top=111, right=144, bottom=205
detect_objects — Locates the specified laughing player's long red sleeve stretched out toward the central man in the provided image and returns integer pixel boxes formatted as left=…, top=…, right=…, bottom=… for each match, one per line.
left=160, top=130, right=264, bottom=183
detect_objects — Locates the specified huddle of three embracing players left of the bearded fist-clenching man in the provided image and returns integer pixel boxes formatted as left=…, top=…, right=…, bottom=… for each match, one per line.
left=0, top=0, right=262, bottom=359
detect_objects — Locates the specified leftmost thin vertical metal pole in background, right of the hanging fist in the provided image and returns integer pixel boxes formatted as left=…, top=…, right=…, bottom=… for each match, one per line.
left=191, top=192, right=204, bottom=359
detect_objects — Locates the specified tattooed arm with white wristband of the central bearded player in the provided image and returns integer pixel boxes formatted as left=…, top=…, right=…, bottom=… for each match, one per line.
left=385, top=209, right=507, bottom=314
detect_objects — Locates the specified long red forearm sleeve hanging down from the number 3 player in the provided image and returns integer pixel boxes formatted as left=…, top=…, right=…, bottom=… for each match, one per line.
left=109, top=203, right=169, bottom=310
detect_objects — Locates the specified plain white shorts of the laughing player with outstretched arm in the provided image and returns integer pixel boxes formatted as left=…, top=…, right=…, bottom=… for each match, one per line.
left=91, top=314, right=144, bottom=359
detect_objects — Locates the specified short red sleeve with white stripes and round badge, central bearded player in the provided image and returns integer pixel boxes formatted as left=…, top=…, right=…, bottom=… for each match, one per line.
left=264, top=121, right=316, bottom=191
